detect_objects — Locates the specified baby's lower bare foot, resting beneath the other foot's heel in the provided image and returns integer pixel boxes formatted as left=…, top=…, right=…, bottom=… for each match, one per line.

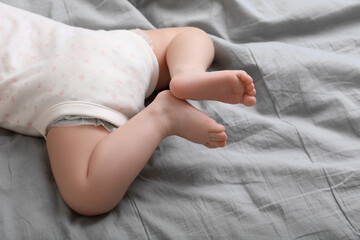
left=153, top=91, right=227, bottom=148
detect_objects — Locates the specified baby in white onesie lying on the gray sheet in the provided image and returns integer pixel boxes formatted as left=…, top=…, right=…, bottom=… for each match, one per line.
left=0, top=4, right=256, bottom=215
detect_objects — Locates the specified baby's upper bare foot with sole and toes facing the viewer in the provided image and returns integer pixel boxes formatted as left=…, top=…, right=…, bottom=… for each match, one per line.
left=170, top=70, right=256, bottom=106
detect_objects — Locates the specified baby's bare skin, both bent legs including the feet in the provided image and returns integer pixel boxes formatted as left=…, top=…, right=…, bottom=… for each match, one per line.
left=47, top=27, right=256, bottom=215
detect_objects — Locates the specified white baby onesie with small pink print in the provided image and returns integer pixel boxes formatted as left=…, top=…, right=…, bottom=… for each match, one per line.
left=0, top=3, right=159, bottom=136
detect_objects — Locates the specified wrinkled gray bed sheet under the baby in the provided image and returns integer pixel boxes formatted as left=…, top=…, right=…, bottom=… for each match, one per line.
left=0, top=0, right=360, bottom=240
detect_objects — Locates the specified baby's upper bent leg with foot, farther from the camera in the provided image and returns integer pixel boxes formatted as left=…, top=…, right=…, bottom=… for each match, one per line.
left=146, top=28, right=256, bottom=106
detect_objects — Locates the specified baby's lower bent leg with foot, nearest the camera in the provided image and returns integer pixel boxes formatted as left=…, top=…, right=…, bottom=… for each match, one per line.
left=47, top=91, right=227, bottom=215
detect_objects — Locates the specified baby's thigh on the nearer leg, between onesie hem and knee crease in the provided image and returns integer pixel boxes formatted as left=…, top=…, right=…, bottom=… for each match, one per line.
left=46, top=125, right=109, bottom=198
